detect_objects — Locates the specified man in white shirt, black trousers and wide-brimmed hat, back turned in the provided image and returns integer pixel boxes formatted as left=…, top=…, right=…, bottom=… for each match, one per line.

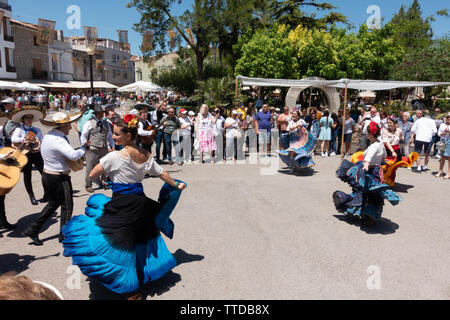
left=23, top=112, right=85, bottom=246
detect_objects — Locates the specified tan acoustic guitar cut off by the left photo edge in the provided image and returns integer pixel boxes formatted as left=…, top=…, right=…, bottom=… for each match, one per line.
left=0, top=148, right=28, bottom=196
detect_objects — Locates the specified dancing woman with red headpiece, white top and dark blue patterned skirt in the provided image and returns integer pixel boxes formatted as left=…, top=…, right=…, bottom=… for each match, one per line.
left=333, top=121, right=401, bottom=226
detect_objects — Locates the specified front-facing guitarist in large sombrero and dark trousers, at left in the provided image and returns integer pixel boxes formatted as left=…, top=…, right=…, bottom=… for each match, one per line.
left=11, top=109, right=48, bottom=206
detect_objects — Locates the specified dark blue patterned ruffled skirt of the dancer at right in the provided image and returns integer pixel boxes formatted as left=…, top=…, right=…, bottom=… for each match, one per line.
left=333, top=160, right=402, bottom=220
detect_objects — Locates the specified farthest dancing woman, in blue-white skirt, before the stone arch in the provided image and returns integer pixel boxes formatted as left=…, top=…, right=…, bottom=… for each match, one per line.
left=278, top=110, right=317, bottom=173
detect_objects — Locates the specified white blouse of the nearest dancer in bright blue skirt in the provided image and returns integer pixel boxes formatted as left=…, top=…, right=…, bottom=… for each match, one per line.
left=100, top=151, right=164, bottom=184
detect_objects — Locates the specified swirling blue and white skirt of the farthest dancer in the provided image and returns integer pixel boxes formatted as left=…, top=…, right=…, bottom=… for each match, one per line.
left=278, top=127, right=317, bottom=169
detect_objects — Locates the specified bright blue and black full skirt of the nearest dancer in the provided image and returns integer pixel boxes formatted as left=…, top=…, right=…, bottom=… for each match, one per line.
left=63, top=152, right=185, bottom=294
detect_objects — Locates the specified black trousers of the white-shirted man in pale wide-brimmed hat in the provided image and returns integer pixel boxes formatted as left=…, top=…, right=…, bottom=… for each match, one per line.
left=27, top=173, right=73, bottom=234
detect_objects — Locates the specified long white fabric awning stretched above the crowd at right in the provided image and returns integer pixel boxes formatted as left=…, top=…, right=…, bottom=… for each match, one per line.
left=236, top=76, right=450, bottom=91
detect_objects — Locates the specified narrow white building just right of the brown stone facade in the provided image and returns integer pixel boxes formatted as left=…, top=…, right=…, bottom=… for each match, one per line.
left=48, top=30, right=74, bottom=81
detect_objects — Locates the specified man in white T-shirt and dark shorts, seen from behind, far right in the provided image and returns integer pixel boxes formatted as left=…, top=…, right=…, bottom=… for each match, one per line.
left=410, top=110, right=437, bottom=172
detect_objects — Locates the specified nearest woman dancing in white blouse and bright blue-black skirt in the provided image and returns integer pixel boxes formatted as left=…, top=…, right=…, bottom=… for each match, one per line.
left=63, top=114, right=186, bottom=300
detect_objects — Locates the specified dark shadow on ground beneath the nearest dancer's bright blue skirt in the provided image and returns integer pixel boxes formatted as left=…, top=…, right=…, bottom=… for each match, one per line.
left=87, top=249, right=205, bottom=300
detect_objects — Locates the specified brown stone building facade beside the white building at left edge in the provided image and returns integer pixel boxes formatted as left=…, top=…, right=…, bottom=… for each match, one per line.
left=11, top=19, right=49, bottom=81
